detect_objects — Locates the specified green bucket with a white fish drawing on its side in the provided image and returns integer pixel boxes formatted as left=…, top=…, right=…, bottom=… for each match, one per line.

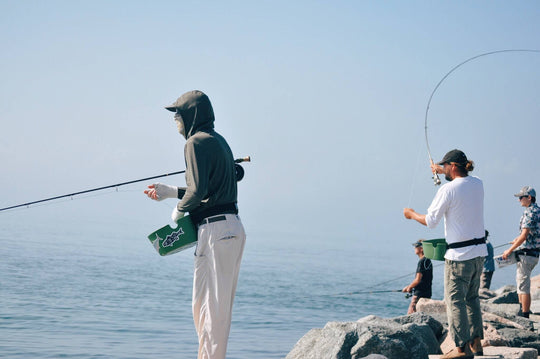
left=148, top=215, right=197, bottom=256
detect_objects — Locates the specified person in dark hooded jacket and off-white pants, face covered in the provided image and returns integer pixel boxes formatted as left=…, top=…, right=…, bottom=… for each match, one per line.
left=145, top=91, right=246, bottom=359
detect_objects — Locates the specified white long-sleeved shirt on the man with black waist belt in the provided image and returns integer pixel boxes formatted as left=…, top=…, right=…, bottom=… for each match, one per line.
left=426, top=176, right=487, bottom=261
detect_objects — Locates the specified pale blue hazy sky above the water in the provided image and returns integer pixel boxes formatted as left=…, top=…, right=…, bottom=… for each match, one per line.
left=0, top=0, right=540, bottom=249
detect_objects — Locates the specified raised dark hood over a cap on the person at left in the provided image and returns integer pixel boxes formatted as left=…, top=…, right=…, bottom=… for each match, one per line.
left=165, top=90, right=215, bottom=139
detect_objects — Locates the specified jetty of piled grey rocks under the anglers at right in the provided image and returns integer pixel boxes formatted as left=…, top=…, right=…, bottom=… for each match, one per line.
left=286, top=276, right=540, bottom=359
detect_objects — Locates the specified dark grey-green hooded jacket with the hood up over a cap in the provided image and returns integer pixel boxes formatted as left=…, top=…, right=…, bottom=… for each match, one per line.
left=167, top=91, right=237, bottom=222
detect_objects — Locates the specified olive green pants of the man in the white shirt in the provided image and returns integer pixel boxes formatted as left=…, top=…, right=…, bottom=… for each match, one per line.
left=444, top=257, right=484, bottom=347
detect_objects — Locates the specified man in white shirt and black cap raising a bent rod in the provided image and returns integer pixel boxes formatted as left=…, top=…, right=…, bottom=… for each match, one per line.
left=403, top=150, right=487, bottom=359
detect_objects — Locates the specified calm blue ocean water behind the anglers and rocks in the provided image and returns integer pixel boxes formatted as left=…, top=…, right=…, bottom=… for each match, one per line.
left=0, top=210, right=513, bottom=359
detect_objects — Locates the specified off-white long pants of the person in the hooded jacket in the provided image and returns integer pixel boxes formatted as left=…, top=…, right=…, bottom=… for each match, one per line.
left=192, top=214, right=246, bottom=359
